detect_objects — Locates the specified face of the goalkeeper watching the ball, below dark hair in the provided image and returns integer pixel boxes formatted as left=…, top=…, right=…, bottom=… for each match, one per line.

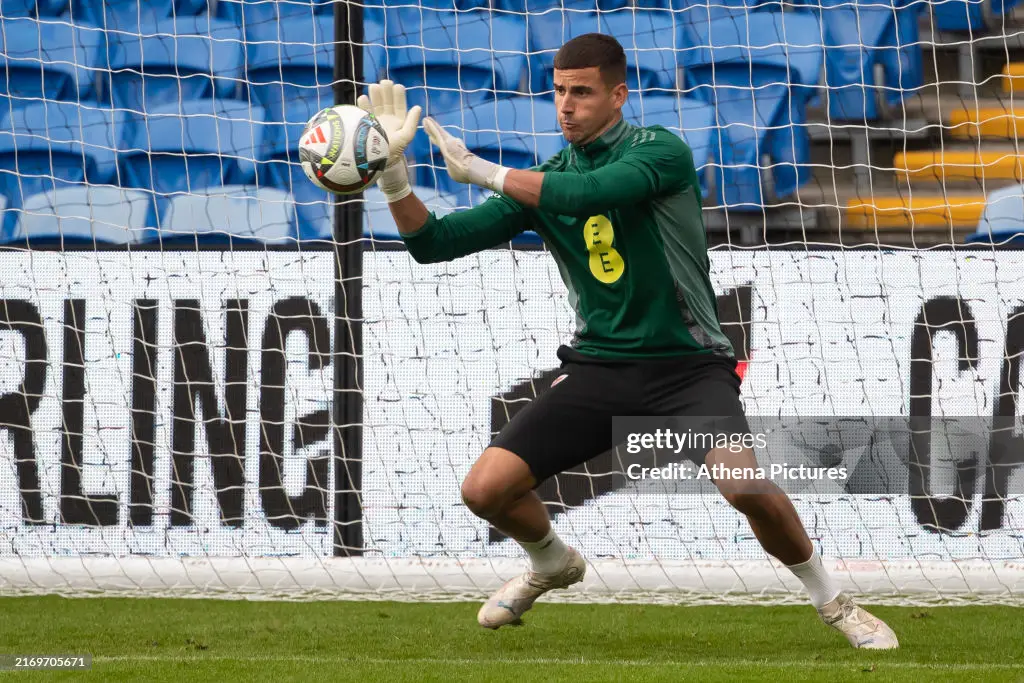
left=554, top=67, right=626, bottom=144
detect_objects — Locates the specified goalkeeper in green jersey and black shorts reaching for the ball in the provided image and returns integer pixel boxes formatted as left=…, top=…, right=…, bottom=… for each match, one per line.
left=359, top=34, right=898, bottom=649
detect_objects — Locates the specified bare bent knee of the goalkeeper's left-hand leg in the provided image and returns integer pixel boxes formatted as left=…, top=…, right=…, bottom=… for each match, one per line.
left=462, top=447, right=534, bottom=519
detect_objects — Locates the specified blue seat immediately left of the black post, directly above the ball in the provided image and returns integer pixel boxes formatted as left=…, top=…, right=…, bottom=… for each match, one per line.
left=246, top=14, right=334, bottom=121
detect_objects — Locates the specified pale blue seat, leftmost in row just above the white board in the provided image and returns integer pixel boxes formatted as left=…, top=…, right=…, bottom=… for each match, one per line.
left=11, top=185, right=155, bottom=245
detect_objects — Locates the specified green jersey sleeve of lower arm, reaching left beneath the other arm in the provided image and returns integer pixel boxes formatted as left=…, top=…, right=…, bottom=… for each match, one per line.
left=401, top=196, right=531, bottom=263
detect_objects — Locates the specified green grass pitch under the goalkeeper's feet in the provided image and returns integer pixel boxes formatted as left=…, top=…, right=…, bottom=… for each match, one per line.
left=0, top=597, right=1024, bottom=683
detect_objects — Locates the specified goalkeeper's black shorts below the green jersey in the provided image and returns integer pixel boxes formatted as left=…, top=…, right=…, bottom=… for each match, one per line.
left=490, top=346, right=750, bottom=484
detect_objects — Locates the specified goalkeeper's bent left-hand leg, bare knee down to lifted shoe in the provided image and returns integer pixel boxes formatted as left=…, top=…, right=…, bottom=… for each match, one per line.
left=462, top=446, right=587, bottom=629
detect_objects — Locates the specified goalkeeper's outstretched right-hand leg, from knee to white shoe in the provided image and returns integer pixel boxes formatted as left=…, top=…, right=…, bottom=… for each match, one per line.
left=706, top=449, right=899, bottom=649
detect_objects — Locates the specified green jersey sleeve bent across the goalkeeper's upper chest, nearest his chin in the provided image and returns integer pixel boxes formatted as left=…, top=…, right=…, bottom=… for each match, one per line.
left=539, top=130, right=693, bottom=215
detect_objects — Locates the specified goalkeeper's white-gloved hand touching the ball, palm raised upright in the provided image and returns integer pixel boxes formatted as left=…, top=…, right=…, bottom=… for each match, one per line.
left=356, top=81, right=423, bottom=203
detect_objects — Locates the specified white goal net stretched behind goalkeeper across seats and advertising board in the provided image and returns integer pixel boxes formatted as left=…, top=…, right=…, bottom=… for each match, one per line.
left=0, top=0, right=1024, bottom=602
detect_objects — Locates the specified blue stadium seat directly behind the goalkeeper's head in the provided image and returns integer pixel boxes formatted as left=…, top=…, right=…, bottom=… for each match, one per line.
left=528, top=9, right=677, bottom=93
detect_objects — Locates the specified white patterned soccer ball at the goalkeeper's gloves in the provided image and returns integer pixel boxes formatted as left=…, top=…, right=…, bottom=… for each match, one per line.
left=299, top=104, right=388, bottom=195
